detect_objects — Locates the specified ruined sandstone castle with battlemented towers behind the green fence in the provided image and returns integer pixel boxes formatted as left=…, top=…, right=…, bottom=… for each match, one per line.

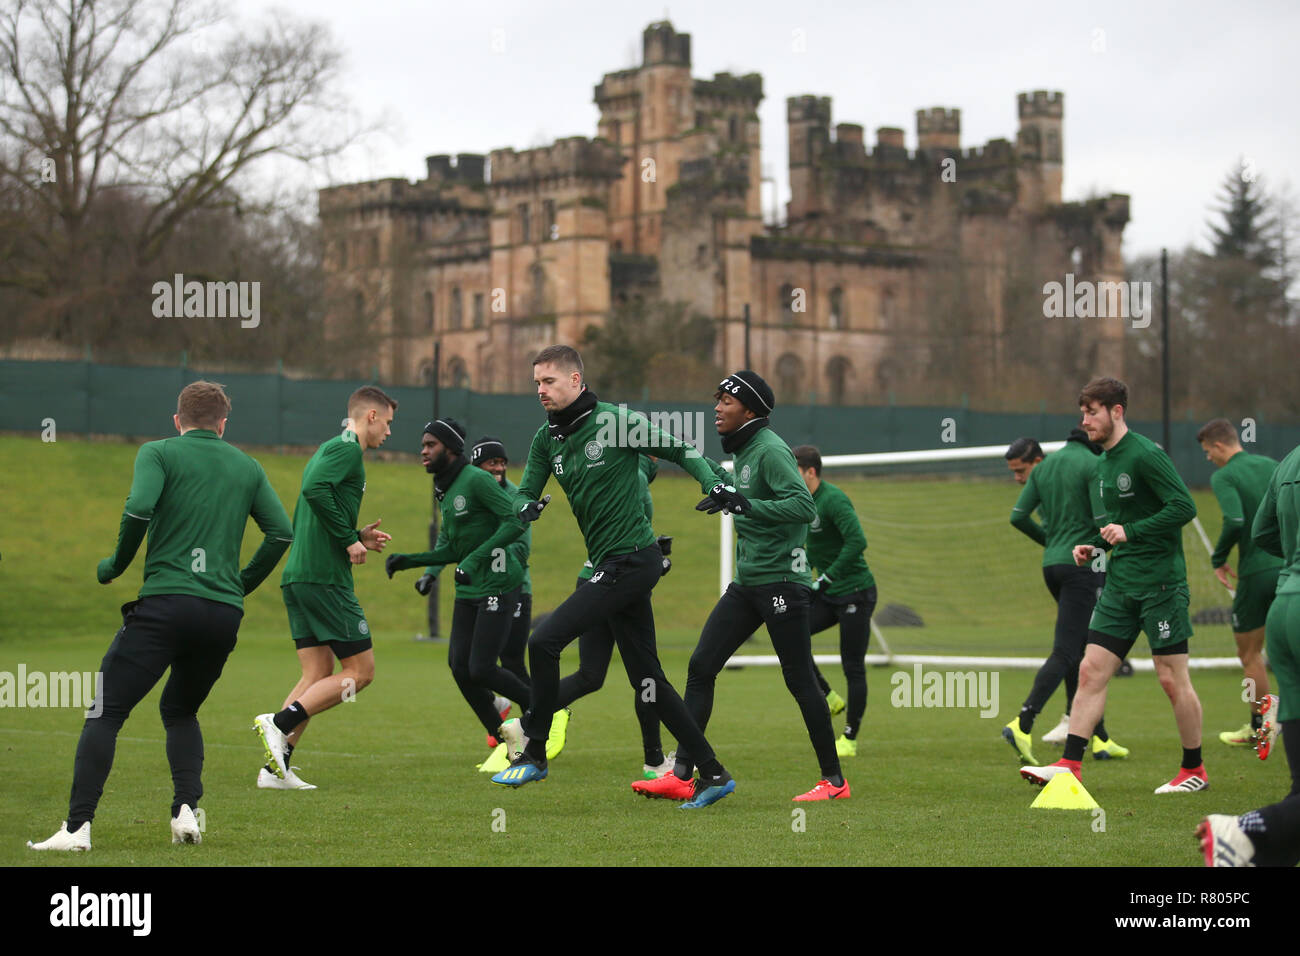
left=320, top=22, right=1128, bottom=403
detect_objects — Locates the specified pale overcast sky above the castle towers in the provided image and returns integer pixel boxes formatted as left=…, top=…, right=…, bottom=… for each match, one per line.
left=242, top=0, right=1300, bottom=258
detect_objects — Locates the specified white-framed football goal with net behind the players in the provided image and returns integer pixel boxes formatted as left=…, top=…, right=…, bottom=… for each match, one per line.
left=719, top=442, right=1240, bottom=669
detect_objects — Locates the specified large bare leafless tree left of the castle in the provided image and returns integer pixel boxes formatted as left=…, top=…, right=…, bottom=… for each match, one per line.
left=0, top=0, right=366, bottom=339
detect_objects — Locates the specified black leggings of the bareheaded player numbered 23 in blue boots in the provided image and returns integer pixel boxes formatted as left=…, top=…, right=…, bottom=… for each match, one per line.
left=524, top=545, right=720, bottom=775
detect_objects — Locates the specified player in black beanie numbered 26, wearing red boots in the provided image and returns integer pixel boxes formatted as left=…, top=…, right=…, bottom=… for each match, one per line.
left=633, top=369, right=850, bottom=800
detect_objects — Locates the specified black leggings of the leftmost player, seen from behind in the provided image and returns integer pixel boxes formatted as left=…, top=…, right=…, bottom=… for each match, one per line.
left=68, top=594, right=243, bottom=831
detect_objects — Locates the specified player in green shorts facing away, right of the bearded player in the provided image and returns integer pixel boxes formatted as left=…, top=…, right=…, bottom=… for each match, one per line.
left=1196, top=419, right=1282, bottom=754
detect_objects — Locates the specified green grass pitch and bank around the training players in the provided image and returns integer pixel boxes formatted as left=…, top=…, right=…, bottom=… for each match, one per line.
left=0, top=438, right=1288, bottom=866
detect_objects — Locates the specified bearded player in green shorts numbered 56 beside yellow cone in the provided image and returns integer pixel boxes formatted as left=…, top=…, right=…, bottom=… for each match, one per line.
left=1021, top=378, right=1209, bottom=793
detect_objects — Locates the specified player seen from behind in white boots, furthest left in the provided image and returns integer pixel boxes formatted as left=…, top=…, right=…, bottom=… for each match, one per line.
left=27, top=381, right=293, bottom=851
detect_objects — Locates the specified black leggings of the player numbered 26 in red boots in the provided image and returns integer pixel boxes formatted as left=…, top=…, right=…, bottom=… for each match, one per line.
left=670, top=581, right=840, bottom=779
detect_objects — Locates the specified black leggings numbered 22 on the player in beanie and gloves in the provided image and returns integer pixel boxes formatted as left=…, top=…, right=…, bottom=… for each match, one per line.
left=447, top=588, right=529, bottom=734
